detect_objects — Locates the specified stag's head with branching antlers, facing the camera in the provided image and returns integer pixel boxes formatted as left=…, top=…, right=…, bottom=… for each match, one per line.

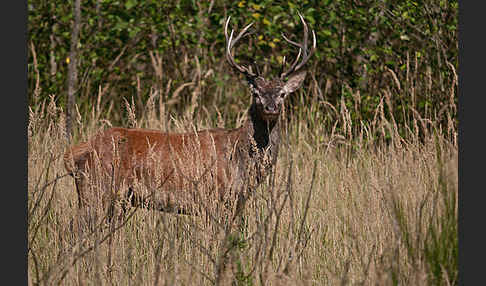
left=224, top=13, right=316, bottom=121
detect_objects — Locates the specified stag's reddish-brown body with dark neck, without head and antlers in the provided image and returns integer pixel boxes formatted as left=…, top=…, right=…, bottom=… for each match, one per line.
left=64, top=105, right=280, bottom=211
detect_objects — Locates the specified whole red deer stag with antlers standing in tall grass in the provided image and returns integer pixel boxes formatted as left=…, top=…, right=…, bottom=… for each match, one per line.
left=64, top=14, right=316, bottom=219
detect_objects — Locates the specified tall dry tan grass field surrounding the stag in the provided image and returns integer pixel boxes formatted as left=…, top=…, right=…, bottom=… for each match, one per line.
left=28, top=69, right=458, bottom=285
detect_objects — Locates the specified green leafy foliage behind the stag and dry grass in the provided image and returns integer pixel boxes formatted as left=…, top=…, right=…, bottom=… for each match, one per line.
left=28, top=0, right=458, bottom=136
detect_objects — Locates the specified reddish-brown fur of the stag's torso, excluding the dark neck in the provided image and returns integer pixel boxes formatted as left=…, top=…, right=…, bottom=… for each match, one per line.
left=64, top=127, right=252, bottom=211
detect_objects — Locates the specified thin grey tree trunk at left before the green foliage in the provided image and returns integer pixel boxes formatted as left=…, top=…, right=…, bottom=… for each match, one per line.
left=66, top=0, right=81, bottom=142
